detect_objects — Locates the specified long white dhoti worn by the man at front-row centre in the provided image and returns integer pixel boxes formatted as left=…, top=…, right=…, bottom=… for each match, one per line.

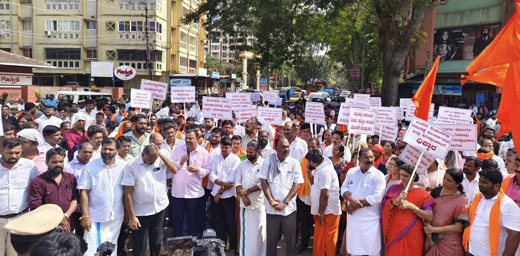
left=239, top=206, right=267, bottom=256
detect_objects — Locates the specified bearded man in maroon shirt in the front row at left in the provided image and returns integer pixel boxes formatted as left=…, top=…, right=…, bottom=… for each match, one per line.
left=29, top=148, right=79, bottom=232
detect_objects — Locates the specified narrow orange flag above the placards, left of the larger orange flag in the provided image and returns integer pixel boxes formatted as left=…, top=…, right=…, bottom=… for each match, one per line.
left=412, top=56, right=441, bottom=121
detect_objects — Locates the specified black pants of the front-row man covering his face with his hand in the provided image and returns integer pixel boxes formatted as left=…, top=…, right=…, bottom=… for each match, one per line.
left=132, top=210, right=164, bottom=256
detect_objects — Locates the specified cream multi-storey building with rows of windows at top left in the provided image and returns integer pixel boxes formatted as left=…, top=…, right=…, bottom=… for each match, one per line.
left=0, top=0, right=204, bottom=88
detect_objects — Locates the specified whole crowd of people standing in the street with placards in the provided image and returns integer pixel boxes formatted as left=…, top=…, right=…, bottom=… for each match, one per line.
left=0, top=92, right=520, bottom=256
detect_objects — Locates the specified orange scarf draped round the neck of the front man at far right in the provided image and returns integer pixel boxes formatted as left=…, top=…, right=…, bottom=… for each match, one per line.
left=462, top=190, right=504, bottom=256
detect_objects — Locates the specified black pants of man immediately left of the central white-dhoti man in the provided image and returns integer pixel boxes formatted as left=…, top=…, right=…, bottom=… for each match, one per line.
left=212, top=197, right=237, bottom=251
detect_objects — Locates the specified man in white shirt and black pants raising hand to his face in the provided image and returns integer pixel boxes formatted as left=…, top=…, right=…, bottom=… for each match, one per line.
left=121, top=145, right=177, bottom=256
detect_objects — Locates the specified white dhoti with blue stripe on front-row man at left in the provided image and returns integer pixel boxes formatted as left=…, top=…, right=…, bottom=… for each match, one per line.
left=83, top=218, right=123, bottom=255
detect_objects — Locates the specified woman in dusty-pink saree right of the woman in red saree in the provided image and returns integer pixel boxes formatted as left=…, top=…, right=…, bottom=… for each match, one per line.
left=424, top=168, right=469, bottom=256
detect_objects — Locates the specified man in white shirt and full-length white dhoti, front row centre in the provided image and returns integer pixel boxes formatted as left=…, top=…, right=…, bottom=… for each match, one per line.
left=235, top=140, right=267, bottom=256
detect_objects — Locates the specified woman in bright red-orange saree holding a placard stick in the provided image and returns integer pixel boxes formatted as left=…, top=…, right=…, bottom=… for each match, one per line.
left=382, top=164, right=435, bottom=256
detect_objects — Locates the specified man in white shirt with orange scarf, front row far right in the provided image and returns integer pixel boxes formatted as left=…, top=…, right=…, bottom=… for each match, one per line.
left=464, top=168, right=520, bottom=255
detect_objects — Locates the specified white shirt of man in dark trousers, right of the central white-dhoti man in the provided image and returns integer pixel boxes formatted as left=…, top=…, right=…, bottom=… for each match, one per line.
left=258, top=154, right=304, bottom=216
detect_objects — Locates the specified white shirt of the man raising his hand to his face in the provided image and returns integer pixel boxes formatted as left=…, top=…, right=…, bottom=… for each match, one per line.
left=121, top=155, right=169, bottom=216
